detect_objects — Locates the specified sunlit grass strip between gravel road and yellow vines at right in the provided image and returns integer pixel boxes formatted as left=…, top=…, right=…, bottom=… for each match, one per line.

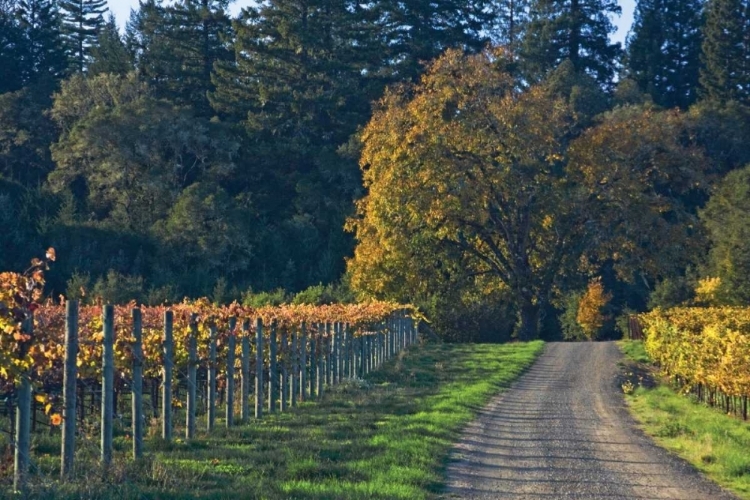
left=619, top=341, right=750, bottom=499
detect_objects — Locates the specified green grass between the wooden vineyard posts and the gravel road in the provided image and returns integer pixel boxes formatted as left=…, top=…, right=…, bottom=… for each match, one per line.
left=0, top=342, right=543, bottom=499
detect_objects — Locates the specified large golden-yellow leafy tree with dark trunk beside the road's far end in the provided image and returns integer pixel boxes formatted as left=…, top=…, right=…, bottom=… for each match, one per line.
left=349, top=51, right=582, bottom=339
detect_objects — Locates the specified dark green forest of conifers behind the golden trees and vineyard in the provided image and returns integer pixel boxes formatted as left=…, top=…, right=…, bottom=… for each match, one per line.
left=0, top=0, right=750, bottom=340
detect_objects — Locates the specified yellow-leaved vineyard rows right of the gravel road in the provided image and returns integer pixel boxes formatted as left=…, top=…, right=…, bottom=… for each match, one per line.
left=640, top=307, right=750, bottom=420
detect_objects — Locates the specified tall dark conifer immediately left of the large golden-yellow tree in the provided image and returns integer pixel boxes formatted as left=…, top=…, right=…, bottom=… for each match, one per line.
left=209, top=0, right=384, bottom=287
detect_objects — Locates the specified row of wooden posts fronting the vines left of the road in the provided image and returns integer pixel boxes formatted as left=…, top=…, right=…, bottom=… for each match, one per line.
left=5, top=301, right=418, bottom=492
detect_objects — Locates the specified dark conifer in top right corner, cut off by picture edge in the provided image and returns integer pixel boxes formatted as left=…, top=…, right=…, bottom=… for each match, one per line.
left=700, top=0, right=750, bottom=105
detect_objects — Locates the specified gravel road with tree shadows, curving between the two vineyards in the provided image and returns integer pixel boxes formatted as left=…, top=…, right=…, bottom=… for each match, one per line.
left=446, top=342, right=735, bottom=500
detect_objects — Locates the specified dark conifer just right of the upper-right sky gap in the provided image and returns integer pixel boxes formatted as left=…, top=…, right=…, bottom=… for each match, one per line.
left=627, top=0, right=704, bottom=109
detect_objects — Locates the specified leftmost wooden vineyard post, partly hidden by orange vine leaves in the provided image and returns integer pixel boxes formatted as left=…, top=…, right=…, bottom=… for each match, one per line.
left=13, top=317, right=34, bottom=493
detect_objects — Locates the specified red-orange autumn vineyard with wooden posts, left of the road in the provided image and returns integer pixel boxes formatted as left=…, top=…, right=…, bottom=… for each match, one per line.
left=0, top=249, right=417, bottom=491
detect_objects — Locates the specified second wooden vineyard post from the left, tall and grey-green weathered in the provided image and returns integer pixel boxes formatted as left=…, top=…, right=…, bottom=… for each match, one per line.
left=60, top=300, right=78, bottom=479
